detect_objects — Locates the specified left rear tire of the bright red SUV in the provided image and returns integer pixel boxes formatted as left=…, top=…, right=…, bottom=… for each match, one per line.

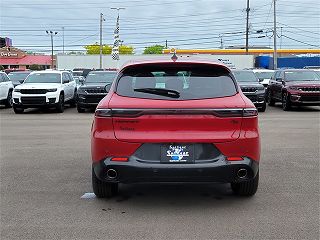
left=92, top=169, right=118, bottom=198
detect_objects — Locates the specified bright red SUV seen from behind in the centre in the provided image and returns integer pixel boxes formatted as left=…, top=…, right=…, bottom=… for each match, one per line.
left=91, top=59, right=260, bottom=197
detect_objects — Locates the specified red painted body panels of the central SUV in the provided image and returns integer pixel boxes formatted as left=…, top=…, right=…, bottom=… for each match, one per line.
left=91, top=60, right=260, bottom=163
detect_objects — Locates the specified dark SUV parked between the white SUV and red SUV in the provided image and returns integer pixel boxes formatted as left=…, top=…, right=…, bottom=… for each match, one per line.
left=77, top=71, right=117, bottom=113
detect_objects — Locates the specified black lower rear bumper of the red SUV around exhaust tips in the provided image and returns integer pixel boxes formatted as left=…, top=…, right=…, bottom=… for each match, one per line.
left=93, top=155, right=259, bottom=183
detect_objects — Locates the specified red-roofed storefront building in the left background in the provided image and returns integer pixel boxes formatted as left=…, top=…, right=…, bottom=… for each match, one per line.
left=0, top=47, right=55, bottom=70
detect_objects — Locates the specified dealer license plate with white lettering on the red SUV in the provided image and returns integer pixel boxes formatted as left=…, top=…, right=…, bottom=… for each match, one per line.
left=161, top=143, right=194, bottom=163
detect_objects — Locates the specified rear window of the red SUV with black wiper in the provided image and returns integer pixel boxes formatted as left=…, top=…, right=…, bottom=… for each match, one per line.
left=116, top=65, right=237, bottom=100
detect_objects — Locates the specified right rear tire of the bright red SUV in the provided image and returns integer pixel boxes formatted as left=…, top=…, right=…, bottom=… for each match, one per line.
left=231, top=171, right=259, bottom=197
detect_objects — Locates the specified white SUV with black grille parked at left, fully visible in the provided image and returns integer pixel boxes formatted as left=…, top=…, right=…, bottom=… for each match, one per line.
left=12, top=70, right=77, bottom=113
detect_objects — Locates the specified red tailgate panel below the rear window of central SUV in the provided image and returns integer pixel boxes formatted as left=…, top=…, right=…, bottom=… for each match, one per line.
left=109, top=94, right=244, bottom=143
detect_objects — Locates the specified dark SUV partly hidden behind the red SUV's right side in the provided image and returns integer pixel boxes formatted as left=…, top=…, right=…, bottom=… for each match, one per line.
left=233, top=70, right=267, bottom=112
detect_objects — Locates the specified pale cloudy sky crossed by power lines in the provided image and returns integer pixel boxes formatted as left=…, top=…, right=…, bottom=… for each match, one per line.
left=0, top=0, right=320, bottom=54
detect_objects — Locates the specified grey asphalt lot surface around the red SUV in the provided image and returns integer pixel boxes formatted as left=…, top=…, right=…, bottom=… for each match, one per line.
left=0, top=106, right=320, bottom=239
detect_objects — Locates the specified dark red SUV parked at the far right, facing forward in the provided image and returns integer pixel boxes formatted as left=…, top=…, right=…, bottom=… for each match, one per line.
left=267, top=69, right=320, bottom=111
